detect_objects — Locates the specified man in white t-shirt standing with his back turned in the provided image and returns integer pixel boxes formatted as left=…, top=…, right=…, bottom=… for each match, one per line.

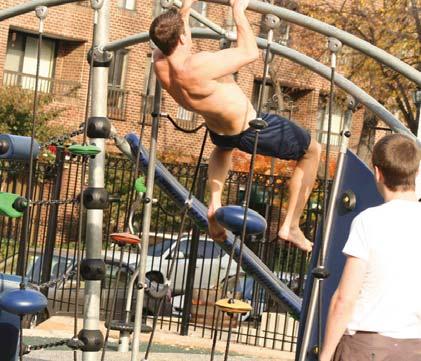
left=319, top=134, right=421, bottom=361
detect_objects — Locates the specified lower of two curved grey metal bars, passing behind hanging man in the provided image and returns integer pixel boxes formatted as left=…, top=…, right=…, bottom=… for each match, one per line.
left=104, top=28, right=421, bottom=147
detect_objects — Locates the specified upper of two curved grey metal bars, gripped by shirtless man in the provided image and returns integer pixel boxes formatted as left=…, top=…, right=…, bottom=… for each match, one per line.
left=199, top=0, right=421, bottom=86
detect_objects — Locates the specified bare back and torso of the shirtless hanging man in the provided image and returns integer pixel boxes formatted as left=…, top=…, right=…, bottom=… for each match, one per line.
left=154, top=50, right=256, bottom=135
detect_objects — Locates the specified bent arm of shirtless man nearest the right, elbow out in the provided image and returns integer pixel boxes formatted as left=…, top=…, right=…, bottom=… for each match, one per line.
left=189, top=0, right=259, bottom=79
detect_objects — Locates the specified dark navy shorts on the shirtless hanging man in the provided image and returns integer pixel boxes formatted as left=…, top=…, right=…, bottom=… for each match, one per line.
left=209, top=113, right=310, bottom=160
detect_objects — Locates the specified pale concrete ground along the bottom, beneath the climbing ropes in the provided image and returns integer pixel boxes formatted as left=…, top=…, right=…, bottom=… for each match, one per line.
left=24, top=316, right=294, bottom=361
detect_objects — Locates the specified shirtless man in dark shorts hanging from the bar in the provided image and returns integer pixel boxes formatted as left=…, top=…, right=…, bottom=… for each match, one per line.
left=149, top=0, right=320, bottom=251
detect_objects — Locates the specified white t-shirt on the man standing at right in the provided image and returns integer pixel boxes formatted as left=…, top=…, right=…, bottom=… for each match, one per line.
left=343, top=200, right=421, bottom=339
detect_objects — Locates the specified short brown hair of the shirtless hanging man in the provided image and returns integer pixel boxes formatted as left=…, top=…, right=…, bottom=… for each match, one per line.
left=149, top=8, right=184, bottom=56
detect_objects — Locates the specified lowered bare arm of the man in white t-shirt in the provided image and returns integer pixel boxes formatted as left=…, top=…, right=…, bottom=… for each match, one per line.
left=319, top=256, right=367, bottom=361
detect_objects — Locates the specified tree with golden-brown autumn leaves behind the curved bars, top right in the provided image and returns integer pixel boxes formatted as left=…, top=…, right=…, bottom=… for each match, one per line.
left=300, top=0, right=421, bottom=158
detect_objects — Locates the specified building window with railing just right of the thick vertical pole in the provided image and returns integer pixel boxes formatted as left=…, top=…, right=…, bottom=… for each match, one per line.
left=108, top=49, right=128, bottom=120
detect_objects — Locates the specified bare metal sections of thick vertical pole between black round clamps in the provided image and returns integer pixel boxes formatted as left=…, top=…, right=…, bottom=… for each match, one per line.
left=82, top=0, right=109, bottom=361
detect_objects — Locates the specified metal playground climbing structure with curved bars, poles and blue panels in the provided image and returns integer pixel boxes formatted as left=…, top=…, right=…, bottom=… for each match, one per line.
left=0, top=0, right=421, bottom=361
